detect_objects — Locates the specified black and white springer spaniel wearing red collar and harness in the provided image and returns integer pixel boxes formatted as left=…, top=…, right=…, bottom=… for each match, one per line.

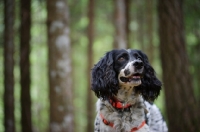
left=92, top=49, right=168, bottom=132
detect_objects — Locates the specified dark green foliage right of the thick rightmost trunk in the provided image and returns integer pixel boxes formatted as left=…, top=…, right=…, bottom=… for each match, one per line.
left=183, top=0, right=200, bottom=103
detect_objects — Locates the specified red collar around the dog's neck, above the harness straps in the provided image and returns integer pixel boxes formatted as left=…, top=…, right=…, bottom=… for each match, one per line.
left=109, top=98, right=131, bottom=109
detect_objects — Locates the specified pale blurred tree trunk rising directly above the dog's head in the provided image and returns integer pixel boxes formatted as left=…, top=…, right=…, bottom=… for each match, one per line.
left=114, top=0, right=127, bottom=49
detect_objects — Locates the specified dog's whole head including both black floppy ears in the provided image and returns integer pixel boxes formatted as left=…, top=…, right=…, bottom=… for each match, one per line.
left=92, top=49, right=162, bottom=101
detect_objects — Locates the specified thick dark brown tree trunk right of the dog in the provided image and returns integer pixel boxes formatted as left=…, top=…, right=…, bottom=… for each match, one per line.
left=158, top=0, right=200, bottom=132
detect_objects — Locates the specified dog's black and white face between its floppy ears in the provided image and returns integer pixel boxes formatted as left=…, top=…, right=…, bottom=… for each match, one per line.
left=114, top=50, right=144, bottom=87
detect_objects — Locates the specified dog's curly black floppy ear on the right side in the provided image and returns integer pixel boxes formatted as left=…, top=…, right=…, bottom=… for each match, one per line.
left=136, top=51, right=162, bottom=102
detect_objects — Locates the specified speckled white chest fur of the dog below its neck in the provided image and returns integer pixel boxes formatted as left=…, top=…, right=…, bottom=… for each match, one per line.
left=98, top=94, right=145, bottom=132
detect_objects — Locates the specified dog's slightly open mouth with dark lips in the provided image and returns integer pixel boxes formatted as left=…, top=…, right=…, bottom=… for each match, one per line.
left=119, top=73, right=142, bottom=83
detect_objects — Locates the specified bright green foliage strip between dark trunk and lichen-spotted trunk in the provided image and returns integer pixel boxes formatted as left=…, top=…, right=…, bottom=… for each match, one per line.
left=30, top=1, right=49, bottom=132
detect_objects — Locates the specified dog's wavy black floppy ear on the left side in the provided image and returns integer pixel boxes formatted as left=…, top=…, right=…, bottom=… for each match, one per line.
left=91, top=51, right=118, bottom=99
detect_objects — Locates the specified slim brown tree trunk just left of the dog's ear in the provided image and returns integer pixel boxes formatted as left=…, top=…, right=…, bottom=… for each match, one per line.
left=87, top=0, right=94, bottom=132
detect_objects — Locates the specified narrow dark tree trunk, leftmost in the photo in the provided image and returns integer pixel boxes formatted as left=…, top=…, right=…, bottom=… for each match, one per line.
left=4, top=0, right=15, bottom=132
